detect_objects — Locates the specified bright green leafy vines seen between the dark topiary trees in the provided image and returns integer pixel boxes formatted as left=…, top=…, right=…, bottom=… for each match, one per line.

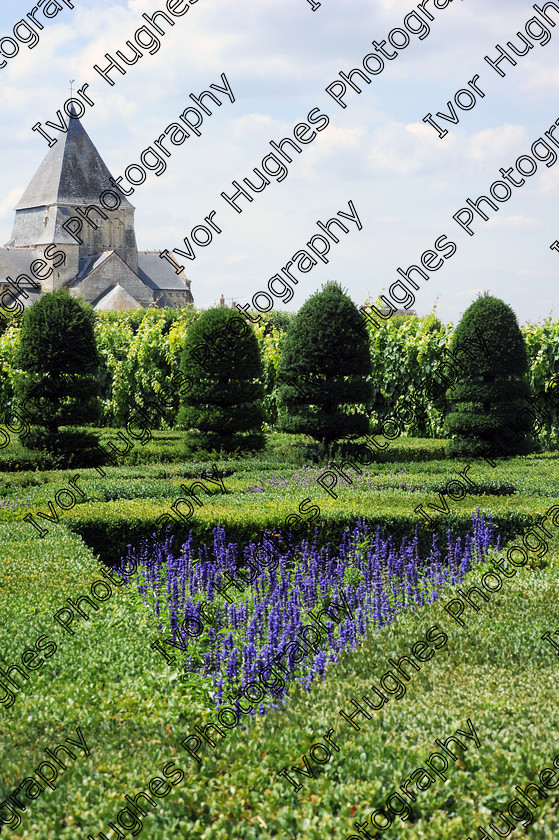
left=0, top=306, right=559, bottom=450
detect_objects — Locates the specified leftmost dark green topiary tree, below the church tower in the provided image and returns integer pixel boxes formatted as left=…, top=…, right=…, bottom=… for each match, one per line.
left=15, top=290, right=100, bottom=465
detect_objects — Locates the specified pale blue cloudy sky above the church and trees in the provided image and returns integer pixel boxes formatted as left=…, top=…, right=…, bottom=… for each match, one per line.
left=0, top=0, right=559, bottom=324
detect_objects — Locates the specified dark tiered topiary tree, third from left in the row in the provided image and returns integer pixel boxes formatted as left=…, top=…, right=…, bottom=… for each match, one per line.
left=278, top=283, right=372, bottom=446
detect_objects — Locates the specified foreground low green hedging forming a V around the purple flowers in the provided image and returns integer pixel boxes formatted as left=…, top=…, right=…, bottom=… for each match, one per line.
left=0, top=496, right=559, bottom=840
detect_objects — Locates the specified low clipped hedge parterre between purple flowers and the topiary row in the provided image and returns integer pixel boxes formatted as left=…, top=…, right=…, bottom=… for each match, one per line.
left=4, top=441, right=558, bottom=563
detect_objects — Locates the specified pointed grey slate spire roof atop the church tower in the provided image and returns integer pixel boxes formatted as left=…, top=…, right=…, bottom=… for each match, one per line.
left=15, top=111, right=132, bottom=210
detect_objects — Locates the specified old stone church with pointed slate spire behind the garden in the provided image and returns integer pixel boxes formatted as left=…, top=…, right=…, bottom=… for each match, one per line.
left=0, top=110, right=193, bottom=311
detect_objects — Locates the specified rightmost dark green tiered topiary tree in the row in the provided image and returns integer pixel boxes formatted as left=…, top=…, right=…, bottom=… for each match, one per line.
left=445, top=294, right=535, bottom=458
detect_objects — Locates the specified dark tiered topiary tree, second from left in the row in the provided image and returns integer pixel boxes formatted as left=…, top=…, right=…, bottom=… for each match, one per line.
left=177, top=307, right=265, bottom=452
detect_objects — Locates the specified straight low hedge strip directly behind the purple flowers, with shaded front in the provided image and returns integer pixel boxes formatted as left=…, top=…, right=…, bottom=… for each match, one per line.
left=19, top=490, right=552, bottom=563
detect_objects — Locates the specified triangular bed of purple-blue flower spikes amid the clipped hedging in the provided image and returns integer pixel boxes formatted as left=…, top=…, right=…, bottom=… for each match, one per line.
left=122, top=513, right=500, bottom=711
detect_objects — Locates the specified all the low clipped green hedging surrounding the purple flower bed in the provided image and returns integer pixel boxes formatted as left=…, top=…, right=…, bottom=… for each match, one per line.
left=0, top=433, right=559, bottom=840
